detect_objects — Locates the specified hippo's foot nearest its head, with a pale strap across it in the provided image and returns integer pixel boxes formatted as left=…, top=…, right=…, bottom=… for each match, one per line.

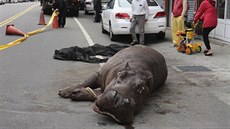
left=69, top=87, right=97, bottom=101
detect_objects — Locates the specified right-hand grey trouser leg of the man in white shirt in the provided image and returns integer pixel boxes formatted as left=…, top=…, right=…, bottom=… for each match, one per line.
left=138, top=15, right=145, bottom=45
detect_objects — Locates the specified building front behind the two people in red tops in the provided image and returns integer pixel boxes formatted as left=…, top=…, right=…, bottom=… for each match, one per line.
left=161, top=0, right=230, bottom=44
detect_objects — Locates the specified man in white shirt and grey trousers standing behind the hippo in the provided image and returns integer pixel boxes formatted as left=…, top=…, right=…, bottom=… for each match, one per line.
left=130, top=0, right=149, bottom=45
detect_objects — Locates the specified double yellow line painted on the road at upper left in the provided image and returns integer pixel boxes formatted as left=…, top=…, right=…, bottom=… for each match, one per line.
left=0, top=4, right=39, bottom=27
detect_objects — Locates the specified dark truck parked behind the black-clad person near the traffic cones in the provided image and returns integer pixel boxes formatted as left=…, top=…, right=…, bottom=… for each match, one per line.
left=42, top=0, right=80, bottom=17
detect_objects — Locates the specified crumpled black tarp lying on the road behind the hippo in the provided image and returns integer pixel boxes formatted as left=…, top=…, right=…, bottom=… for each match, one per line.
left=53, top=44, right=129, bottom=63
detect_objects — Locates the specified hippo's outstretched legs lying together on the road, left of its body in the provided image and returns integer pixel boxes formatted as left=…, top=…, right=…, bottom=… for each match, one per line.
left=58, top=73, right=100, bottom=101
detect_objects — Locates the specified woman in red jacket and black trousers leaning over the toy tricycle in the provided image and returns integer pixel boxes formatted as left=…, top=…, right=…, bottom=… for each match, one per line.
left=194, top=0, right=217, bottom=56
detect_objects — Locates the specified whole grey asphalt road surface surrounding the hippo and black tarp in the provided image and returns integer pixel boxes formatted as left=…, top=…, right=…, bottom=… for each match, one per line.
left=0, top=2, right=230, bottom=129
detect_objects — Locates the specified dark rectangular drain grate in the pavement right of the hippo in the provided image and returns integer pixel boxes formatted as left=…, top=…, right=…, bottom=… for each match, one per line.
left=176, top=66, right=212, bottom=72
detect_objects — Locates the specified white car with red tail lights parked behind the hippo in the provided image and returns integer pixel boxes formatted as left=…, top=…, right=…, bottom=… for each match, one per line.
left=101, top=0, right=166, bottom=41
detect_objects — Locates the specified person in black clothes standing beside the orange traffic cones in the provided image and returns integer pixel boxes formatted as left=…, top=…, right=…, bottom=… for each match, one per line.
left=54, top=0, right=66, bottom=28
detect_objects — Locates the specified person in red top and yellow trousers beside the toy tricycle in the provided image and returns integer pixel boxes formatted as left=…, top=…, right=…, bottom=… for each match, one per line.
left=171, top=0, right=189, bottom=46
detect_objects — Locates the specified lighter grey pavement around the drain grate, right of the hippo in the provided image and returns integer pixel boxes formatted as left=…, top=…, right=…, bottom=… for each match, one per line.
left=153, top=29, right=230, bottom=106
